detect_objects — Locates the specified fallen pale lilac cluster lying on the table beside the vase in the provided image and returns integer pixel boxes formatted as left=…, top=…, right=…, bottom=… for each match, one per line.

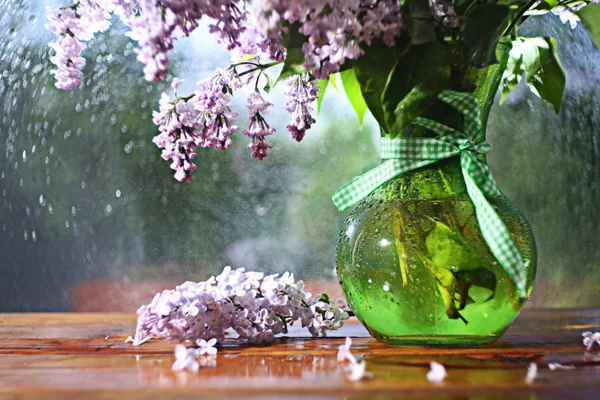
left=134, top=267, right=348, bottom=344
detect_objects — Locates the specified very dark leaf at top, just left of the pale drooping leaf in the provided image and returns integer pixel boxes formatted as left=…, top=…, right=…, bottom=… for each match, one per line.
left=463, top=4, right=510, bottom=67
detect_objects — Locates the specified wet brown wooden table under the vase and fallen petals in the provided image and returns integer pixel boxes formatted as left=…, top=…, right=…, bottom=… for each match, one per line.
left=0, top=309, right=600, bottom=400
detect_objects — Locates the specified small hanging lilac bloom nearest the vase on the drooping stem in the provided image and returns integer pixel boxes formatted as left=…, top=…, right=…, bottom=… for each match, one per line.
left=283, top=74, right=319, bottom=142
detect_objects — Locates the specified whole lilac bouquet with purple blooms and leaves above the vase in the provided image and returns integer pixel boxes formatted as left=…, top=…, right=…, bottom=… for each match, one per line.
left=48, top=0, right=600, bottom=181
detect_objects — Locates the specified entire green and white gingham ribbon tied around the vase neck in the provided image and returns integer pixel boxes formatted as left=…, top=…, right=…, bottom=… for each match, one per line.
left=332, top=90, right=526, bottom=297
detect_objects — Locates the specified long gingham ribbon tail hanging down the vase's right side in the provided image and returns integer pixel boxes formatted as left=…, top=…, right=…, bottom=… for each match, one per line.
left=461, top=153, right=527, bottom=298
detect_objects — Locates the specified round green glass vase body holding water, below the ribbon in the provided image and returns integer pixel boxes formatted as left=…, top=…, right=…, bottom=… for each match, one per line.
left=336, top=157, right=536, bottom=346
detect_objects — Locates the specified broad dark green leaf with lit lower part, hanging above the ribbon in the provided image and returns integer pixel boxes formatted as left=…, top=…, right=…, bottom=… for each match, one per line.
left=382, top=42, right=450, bottom=136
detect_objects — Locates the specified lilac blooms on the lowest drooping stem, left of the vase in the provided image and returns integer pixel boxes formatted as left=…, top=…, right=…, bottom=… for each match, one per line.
left=153, top=66, right=319, bottom=182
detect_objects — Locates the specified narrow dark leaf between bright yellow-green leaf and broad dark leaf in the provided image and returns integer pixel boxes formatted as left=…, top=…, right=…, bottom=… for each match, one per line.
left=354, top=41, right=400, bottom=131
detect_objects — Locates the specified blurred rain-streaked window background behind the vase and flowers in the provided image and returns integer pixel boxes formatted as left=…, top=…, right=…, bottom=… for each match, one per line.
left=0, top=0, right=600, bottom=312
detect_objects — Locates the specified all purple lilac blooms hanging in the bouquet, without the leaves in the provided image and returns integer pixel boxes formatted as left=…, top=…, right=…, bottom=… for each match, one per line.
left=47, top=0, right=403, bottom=181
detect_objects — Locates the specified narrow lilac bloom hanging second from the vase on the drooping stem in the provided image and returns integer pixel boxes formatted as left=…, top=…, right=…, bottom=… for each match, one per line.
left=243, top=91, right=275, bottom=160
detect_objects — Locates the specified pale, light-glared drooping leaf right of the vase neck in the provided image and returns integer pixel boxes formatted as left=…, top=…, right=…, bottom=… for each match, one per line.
left=500, top=37, right=566, bottom=113
